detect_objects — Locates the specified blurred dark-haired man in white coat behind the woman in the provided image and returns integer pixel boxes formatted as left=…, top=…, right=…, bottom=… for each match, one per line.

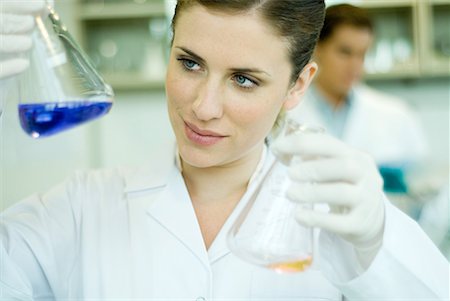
left=290, top=4, right=426, bottom=192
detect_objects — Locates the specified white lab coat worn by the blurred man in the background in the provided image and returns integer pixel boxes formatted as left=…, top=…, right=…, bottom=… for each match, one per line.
left=289, top=84, right=427, bottom=167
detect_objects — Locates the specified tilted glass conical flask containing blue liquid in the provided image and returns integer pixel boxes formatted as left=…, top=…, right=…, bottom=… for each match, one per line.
left=18, top=2, right=114, bottom=138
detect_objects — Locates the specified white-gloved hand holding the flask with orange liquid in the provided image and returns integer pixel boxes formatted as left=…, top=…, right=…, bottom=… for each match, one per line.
left=273, top=133, right=384, bottom=269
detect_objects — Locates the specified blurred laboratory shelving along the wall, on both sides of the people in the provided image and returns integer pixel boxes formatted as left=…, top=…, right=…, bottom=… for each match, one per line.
left=68, top=0, right=450, bottom=90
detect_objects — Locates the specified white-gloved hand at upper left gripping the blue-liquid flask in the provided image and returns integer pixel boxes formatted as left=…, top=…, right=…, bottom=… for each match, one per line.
left=0, top=0, right=46, bottom=79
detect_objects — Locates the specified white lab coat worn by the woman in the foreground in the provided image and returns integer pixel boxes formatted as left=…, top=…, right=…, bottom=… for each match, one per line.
left=0, top=146, right=449, bottom=301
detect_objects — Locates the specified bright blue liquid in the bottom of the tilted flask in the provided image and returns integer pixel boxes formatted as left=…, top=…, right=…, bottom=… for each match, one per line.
left=19, top=101, right=112, bottom=138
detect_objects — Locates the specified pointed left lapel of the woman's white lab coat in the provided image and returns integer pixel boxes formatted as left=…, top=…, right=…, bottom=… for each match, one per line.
left=147, top=167, right=209, bottom=269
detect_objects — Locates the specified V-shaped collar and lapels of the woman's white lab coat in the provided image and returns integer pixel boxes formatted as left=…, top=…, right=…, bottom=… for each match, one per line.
left=125, top=147, right=274, bottom=269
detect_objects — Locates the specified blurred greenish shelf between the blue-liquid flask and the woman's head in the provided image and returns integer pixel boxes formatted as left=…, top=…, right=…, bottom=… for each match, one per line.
left=78, top=0, right=170, bottom=90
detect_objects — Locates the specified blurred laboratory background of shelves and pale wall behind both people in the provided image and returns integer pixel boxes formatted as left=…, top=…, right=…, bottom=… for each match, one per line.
left=0, top=0, right=450, bottom=258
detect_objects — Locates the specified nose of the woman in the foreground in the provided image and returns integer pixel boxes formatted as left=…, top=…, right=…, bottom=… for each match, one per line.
left=192, top=77, right=224, bottom=121
